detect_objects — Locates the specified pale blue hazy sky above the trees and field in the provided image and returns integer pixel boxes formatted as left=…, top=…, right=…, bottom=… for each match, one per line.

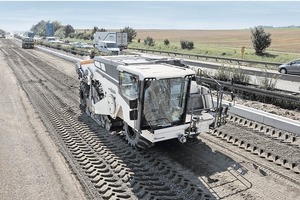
left=0, top=0, right=300, bottom=32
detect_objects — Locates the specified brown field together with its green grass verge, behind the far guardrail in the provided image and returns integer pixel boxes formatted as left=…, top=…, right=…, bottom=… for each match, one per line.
left=129, top=28, right=300, bottom=63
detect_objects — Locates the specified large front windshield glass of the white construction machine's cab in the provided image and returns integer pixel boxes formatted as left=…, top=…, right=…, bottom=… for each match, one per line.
left=143, top=78, right=189, bottom=128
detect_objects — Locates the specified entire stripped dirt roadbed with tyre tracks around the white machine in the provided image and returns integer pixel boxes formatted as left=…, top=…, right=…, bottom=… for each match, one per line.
left=0, top=39, right=300, bottom=200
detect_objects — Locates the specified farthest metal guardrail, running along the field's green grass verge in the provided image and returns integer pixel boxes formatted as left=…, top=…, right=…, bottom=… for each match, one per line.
left=127, top=47, right=282, bottom=67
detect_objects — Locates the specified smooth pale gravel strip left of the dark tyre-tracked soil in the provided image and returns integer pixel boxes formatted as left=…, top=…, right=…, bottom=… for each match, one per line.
left=0, top=43, right=86, bottom=200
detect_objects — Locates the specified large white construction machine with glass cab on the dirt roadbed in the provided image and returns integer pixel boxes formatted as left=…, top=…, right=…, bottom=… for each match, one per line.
left=76, top=55, right=227, bottom=148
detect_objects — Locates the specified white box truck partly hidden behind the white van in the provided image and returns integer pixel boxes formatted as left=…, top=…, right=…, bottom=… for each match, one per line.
left=93, top=32, right=128, bottom=50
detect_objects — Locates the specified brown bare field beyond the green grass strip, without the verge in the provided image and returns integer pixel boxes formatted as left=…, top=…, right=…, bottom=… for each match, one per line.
left=136, top=28, right=300, bottom=53
